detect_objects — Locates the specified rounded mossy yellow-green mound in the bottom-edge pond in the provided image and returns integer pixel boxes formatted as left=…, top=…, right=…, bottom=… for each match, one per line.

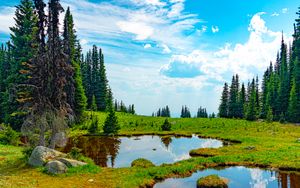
left=197, top=175, right=228, bottom=188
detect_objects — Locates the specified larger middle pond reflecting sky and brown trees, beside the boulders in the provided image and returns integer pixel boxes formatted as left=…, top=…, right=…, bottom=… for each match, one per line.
left=63, top=136, right=223, bottom=168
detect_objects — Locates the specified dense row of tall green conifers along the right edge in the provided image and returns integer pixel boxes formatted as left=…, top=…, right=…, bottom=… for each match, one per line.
left=219, top=8, right=300, bottom=123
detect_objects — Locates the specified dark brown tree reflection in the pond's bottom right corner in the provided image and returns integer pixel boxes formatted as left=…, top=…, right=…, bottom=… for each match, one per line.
left=278, top=173, right=300, bottom=188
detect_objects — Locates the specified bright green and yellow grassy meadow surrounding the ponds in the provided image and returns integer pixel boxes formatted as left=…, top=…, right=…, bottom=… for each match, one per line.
left=0, top=113, right=300, bottom=187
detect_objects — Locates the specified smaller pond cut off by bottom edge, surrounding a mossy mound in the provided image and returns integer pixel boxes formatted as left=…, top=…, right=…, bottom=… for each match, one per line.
left=154, top=167, right=300, bottom=188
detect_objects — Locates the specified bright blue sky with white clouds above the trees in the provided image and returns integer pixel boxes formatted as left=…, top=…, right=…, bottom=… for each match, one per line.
left=0, top=0, right=300, bottom=117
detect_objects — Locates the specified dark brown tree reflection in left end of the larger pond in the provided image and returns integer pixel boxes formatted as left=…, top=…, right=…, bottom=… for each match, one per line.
left=64, top=136, right=121, bottom=167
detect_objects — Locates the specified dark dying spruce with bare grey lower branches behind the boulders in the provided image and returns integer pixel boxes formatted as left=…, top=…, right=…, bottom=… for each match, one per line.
left=22, top=0, right=73, bottom=148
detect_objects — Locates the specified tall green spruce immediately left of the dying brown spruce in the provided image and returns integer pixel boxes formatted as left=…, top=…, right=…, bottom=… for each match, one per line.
left=4, top=0, right=37, bottom=130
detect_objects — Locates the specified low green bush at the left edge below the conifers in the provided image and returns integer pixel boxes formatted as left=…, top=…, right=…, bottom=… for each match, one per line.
left=0, top=124, right=19, bottom=145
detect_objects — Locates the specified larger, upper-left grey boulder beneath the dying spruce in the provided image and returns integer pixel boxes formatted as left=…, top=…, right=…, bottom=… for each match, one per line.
left=28, top=146, right=66, bottom=167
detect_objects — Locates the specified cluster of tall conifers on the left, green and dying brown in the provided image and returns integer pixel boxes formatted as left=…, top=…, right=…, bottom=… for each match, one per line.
left=0, top=0, right=122, bottom=147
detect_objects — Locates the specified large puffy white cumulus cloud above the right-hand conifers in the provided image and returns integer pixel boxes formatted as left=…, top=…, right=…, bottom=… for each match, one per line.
left=160, top=13, right=281, bottom=81
